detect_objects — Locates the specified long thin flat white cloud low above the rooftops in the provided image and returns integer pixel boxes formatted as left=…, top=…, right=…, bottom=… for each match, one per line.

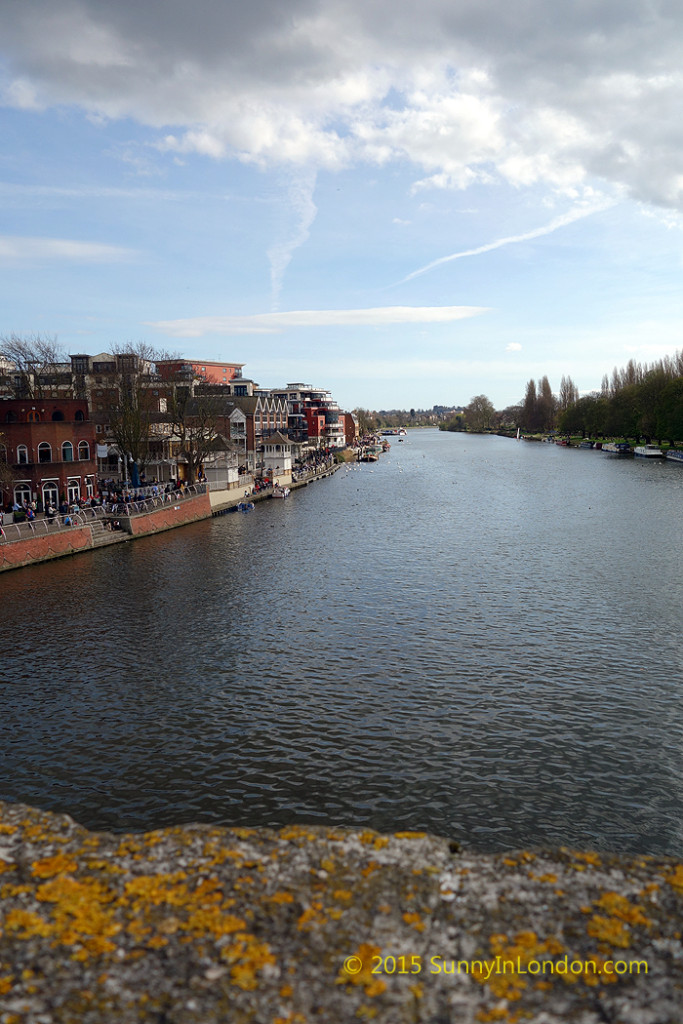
left=146, top=306, right=487, bottom=338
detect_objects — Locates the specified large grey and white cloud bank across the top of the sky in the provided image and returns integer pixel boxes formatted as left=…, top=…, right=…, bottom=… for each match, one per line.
left=0, top=0, right=683, bottom=208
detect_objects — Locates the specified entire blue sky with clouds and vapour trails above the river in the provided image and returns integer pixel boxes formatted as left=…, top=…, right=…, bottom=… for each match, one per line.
left=0, top=0, right=683, bottom=410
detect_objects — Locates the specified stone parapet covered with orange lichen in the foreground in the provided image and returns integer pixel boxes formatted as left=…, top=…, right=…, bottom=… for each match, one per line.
left=0, top=803, right=683, bottom=1024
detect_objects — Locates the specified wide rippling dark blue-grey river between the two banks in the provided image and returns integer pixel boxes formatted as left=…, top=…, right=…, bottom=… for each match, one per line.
left=0, top=430, right=683, bottom=856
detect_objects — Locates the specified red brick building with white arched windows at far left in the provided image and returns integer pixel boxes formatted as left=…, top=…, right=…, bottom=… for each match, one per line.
left=0, top=398, right=97, bottom=507
